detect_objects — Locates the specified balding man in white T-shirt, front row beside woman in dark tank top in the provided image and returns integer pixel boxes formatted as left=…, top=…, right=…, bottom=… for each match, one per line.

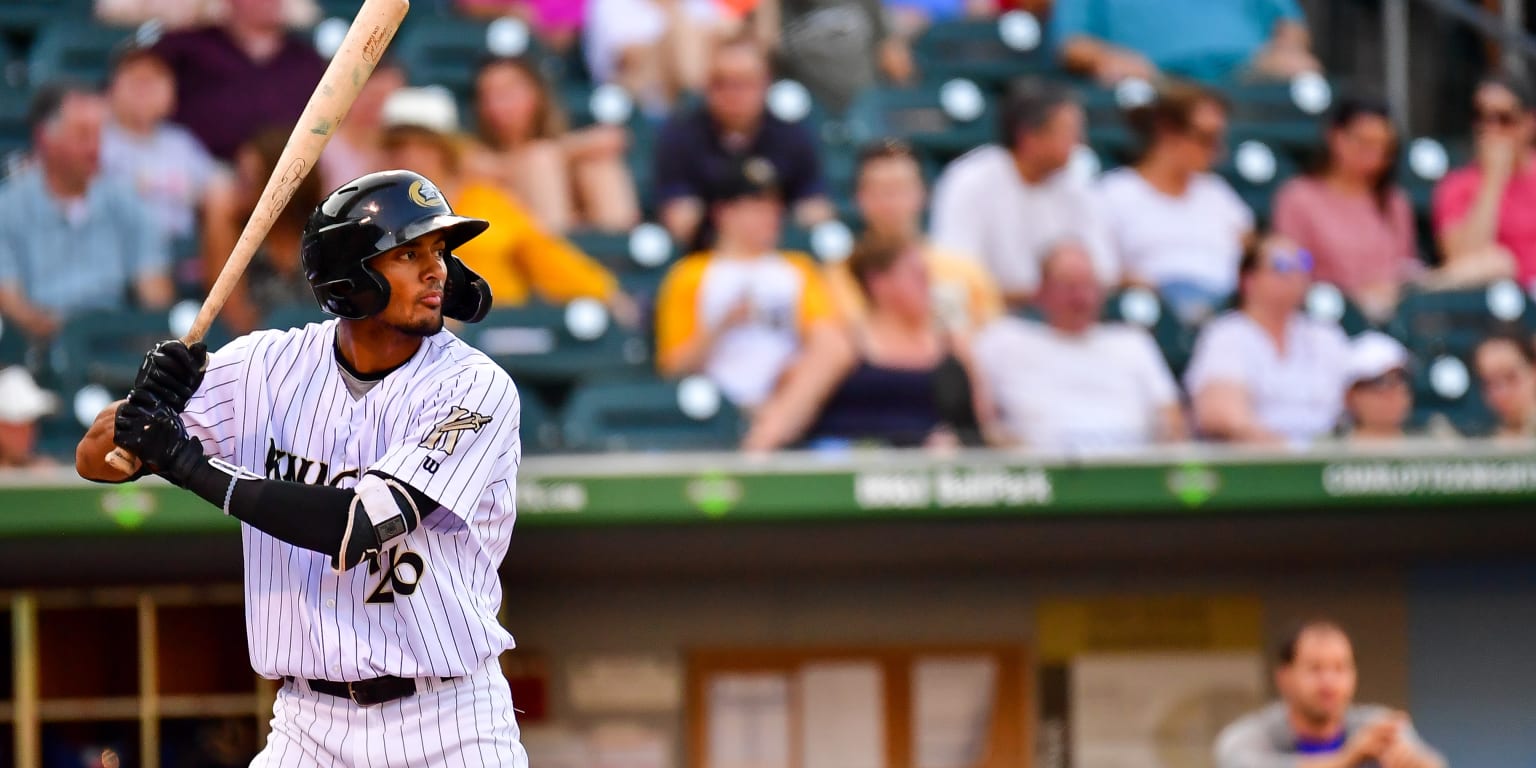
left=975, top=243, right=1187, bottom=453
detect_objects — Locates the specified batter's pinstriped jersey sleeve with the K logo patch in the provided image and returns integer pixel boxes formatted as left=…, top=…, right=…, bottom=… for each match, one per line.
left=369, top=364, right=522, bottom=521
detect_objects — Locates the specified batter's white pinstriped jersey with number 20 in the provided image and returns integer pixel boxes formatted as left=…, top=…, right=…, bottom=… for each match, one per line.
left=183, top=319, right=522, bottom=680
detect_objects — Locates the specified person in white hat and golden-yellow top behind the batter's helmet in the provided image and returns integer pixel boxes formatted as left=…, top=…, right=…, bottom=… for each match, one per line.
left=384, top=88, right=639, bottom=327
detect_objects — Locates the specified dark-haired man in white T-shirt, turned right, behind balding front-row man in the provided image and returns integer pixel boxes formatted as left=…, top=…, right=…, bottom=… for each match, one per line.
left=932, top=80, right=1120, bottom=307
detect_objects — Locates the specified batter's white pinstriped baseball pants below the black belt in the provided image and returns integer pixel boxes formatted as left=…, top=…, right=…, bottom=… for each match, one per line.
left=250, top=662, right=528, bottom=768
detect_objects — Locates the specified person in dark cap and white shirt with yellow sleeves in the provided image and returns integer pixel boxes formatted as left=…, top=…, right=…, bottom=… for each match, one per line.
left=656, top=157, right=840, bottom=409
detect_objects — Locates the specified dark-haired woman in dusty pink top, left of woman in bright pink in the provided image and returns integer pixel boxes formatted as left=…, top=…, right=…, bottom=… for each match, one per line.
left=1273, top=101, right=1422, bottom=319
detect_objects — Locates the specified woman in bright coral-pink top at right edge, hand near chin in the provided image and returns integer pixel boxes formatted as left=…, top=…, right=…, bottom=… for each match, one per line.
left=1435, top=78, right=1536, bottom=286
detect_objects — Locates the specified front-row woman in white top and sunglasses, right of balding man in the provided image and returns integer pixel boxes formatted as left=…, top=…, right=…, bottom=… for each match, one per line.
left=1184, top=237, right=1350, bottom=445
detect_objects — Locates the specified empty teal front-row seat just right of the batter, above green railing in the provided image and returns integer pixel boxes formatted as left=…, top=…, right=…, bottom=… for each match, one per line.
left=561, top=379, right=742, bottom=452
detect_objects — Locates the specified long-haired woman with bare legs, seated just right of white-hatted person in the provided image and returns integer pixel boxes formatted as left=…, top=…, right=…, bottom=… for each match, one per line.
left=468, top=58, right=641, bottom=232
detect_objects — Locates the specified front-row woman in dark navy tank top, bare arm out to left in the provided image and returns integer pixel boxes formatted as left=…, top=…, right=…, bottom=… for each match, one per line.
left=742, top=233, right=991, bottom=452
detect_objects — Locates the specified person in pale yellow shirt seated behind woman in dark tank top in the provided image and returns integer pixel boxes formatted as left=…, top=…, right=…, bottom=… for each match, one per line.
left=826, top=140, right=1003, bottom=333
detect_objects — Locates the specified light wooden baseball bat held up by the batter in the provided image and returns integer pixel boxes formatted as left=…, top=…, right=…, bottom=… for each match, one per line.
left=106, top=0, right=410, bottom=475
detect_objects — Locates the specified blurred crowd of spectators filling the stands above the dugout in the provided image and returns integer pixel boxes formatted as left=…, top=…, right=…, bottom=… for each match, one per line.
left=0, top=0, right=1536, bottom=464
